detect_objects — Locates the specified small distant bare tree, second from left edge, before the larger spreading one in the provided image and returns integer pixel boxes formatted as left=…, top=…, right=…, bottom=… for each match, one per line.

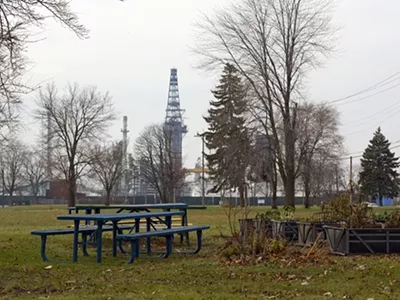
left=23, top=151, right=47, bottom=197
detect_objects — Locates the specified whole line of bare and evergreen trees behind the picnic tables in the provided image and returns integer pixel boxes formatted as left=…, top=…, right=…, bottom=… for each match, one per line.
left=0, top=0, right=398, bottom=207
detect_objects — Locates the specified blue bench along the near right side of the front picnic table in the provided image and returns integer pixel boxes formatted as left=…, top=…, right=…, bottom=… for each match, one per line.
left=116, top=225, right=210, bottom=264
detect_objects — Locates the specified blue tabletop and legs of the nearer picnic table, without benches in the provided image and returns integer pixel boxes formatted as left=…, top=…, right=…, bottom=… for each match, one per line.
left=57, top=211, right=185, bottom=263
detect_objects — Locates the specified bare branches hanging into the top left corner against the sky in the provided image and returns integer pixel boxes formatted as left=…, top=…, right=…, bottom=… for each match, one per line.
left=0, top=0, right=88, bottom=135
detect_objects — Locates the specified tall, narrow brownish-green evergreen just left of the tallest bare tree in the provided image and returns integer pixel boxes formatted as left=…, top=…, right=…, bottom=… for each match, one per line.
left=204, top=64, right=251, bottom=206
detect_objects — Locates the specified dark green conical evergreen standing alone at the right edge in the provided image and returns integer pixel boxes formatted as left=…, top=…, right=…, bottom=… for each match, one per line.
left=359, top=128, right=400, bottom=206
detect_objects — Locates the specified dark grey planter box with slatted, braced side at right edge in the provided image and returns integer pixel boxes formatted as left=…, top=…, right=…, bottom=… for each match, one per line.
left=324, top=226, right=400, bottom=255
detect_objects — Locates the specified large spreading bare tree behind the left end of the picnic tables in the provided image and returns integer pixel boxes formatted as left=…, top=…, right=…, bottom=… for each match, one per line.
left=37, top=84, right=115, bottom=207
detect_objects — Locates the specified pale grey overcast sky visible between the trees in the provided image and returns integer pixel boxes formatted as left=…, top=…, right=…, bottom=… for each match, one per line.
left=22, top=0, right=400, bottom=166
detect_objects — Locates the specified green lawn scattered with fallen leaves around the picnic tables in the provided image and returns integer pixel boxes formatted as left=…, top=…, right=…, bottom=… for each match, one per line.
left=0, top=206, right=400, bottom=300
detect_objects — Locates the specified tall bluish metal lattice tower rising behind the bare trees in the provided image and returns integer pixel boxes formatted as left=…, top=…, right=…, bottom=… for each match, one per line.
left=165, top=68, right=188, bottom=165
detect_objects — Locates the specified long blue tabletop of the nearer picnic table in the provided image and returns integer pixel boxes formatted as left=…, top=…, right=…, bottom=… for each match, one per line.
left=57, top=211, right=185, bottom=221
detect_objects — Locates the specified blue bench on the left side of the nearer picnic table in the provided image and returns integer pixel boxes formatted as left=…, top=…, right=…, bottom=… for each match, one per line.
left=31, top=225, right=132, bottom=261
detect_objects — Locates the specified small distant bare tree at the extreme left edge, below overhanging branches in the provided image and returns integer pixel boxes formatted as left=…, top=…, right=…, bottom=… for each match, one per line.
left=1, top=139, right=26, bottom=196
